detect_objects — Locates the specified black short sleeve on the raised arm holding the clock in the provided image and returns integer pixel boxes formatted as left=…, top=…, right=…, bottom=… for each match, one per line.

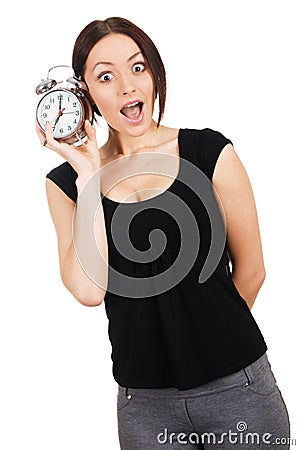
left=46, top=161, right=78, bottom=203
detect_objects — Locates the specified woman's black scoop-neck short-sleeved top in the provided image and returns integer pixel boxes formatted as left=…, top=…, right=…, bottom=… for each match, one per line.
left=47, top=128, right=267, bottom=389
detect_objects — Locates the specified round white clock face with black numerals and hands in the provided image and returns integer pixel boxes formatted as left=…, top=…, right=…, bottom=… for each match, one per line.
left=37, top=89, right=83, bottom=139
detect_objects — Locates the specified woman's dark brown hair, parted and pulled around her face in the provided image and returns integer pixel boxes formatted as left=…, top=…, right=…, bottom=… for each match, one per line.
left=72, top=17, right=166, bottom=126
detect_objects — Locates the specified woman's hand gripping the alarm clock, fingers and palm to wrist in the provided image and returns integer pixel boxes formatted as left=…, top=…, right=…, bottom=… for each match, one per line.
left=36, top=120, right=100, bottom=176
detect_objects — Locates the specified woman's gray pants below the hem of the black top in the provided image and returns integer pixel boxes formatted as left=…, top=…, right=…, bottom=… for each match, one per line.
left=117, top=354, right=290, bottom=450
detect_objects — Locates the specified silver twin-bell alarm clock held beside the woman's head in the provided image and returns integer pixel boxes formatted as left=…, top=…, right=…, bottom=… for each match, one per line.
left=35, top=65, right=94, bottom=144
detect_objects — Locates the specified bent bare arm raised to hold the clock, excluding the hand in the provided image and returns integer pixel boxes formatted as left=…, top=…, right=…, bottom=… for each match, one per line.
left=46, top=171, right=107, bottom=306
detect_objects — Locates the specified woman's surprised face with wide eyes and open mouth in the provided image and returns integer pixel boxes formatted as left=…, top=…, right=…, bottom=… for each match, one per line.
left=84, top=34, right=155, bottom=136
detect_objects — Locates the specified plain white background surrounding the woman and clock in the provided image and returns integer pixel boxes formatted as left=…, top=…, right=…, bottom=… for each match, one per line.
left=0, top=0, right=300, bottom=450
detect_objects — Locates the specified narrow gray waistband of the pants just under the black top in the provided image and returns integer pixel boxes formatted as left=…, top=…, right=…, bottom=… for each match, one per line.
left=118, top=353, right=270, bottom=397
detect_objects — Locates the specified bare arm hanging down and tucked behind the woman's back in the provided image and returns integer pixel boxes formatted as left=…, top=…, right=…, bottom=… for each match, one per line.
left=212, top=144, right=266, bottom=308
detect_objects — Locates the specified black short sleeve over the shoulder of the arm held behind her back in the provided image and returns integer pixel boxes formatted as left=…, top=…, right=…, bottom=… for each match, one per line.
left=198, top=128, right=232, bottom=181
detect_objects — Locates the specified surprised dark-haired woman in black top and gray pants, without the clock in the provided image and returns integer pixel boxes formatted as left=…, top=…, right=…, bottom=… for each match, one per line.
left=38, top=17, right=289, bottom=450
